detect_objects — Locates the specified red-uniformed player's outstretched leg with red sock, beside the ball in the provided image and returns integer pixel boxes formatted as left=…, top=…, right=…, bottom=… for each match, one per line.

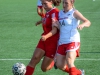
left=25, top=48, right=45, bottom=75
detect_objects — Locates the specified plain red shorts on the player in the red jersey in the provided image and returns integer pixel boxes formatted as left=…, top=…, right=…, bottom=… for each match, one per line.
left=37, top=40, right=58, bottom=58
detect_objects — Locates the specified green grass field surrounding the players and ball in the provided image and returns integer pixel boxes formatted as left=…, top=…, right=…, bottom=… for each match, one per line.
left=0, top=0, right=100, bottom=75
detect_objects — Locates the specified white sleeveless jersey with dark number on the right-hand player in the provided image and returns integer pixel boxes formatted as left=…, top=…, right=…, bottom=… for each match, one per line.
left=59, top=9, right=80, bottom=45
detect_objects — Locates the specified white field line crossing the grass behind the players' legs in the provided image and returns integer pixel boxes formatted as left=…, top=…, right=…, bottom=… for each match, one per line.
left=0, top=58, right=100, bottom=61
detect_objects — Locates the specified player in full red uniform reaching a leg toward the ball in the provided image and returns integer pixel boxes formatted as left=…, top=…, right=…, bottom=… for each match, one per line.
left=25, top=0, right=61, bottom=75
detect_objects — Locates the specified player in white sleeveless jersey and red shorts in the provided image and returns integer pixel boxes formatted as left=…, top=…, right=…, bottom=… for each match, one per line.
left=55, top=0, right=91, bottom=75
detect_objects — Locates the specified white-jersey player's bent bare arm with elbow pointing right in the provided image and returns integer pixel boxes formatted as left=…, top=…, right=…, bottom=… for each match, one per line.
left=74, top=11, right=91, bottom=30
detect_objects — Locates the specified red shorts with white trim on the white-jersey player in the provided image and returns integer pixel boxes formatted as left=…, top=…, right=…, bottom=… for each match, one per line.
left=57, top=42, right=80, bottom=57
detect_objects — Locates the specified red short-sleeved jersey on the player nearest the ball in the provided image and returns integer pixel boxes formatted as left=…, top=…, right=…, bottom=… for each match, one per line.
left=42, top=7, right=59, bottom=40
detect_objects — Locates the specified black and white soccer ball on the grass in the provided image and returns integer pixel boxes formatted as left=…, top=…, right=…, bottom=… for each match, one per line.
left=12, top=63, right=26, bottom=75
